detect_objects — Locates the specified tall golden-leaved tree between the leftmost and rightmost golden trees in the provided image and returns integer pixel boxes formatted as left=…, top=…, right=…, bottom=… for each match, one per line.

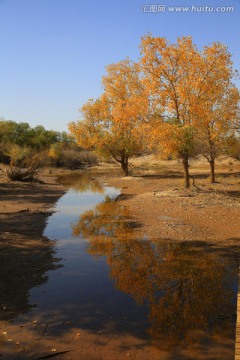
left=140, top=35, right=201, bottom=187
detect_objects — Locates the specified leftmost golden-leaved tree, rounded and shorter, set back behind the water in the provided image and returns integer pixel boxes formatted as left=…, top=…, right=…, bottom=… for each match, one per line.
left=69, top=59, right=148, bottom=176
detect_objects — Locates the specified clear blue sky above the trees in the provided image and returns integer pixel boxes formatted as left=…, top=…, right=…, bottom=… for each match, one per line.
left=0, top=0, right=240, bottom=131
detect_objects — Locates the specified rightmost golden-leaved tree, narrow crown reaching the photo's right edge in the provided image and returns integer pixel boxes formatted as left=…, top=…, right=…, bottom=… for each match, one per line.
left=194, top=42, right=240, bottom=183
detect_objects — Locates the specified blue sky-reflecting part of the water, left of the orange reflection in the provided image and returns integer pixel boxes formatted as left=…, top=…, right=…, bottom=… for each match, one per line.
left=25, top=174, right=147, bottom=336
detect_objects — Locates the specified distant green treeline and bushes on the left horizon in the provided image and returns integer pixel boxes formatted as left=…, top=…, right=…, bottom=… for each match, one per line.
left=0, top=120, right=96, bottom=173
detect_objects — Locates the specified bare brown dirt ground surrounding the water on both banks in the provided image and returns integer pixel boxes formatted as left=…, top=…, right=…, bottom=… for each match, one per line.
left=0, top=163, right=240, bottom=360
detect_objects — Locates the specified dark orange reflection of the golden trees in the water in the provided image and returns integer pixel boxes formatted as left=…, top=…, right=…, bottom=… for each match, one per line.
left=73, top=198, right=237, bottom=348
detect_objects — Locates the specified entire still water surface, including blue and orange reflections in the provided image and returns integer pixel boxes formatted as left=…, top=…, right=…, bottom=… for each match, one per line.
left=19, top=174, right=237, bottom=352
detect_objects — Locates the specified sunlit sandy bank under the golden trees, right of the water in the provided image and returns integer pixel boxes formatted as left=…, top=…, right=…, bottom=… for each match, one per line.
left=106, top=175, right=240, bottom=245
